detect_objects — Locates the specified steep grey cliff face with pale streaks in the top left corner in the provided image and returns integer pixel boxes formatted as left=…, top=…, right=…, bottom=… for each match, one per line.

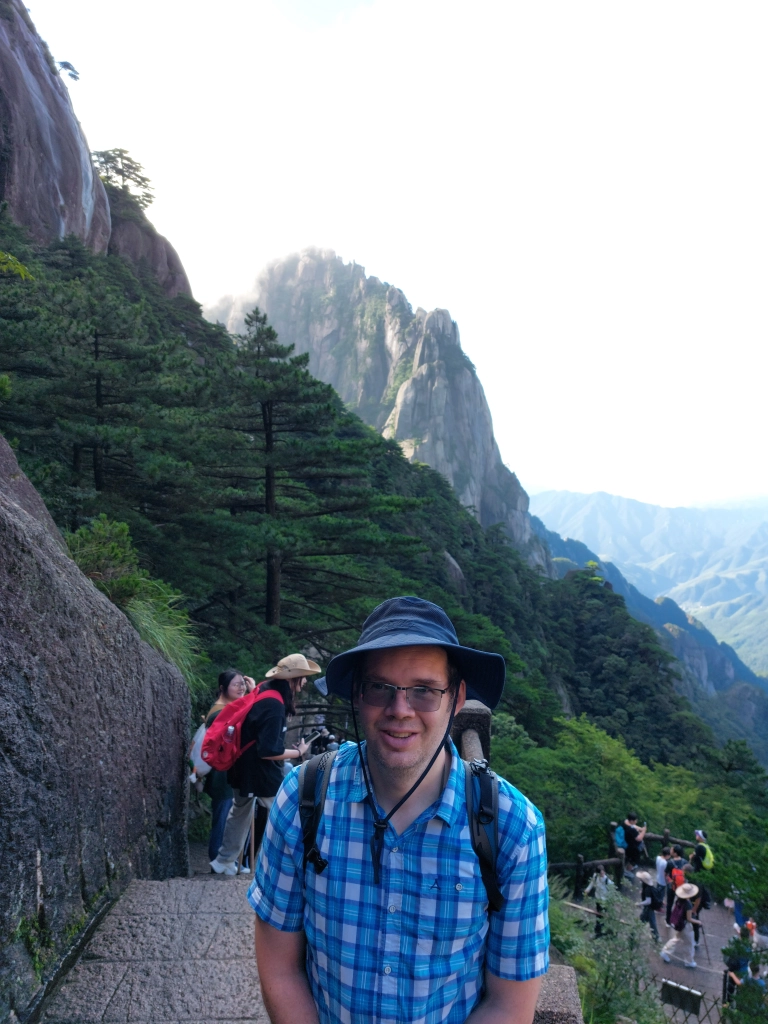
left=0, top=0, right=110, bottom=252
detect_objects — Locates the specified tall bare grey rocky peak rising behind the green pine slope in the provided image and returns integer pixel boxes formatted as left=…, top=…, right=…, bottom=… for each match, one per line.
left=208, top=249, right=550, bottom=570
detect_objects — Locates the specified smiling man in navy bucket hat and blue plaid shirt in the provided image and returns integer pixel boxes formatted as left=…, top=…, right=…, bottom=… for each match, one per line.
left=249, top=597, right=549, bottom=1024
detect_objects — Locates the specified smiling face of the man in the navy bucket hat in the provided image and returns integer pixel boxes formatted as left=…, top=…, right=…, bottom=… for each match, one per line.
left=355, top=647, right=466, bottom=773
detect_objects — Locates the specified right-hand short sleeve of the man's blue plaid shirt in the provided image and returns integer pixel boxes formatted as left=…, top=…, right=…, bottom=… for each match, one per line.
left=485, top=785, right=549, bottom=981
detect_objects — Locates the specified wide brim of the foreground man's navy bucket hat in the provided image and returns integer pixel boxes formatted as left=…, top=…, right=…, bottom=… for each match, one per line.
left=326, top=633, right=506, bottom=711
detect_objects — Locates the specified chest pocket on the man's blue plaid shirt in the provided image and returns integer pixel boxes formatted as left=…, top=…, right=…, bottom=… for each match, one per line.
left=416, top=876, right=488, bottom=975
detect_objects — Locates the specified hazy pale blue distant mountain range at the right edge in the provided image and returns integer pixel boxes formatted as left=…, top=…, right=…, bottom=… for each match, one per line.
left=530, top=490, right=768, bottom=675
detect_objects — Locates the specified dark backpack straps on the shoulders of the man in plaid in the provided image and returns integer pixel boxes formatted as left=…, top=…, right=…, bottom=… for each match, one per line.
left=299, top=753, right=504, bottom=913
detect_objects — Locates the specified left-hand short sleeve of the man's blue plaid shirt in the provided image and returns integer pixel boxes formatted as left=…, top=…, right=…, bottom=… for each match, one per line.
left=248, top=768, right=304, bottom=932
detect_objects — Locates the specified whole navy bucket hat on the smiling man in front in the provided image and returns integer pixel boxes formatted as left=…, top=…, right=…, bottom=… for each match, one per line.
left=318, top=597, right=506, bottom=709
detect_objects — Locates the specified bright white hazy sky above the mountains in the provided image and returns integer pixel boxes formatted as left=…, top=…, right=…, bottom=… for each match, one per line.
left=28, top=0, right=768, bottom=505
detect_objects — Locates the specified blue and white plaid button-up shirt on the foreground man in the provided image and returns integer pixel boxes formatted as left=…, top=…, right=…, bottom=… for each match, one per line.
left=248, top=743, right=549, bottom=1024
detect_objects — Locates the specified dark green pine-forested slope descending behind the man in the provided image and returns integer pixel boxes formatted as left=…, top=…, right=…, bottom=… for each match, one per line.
left=0, top=207, right=765, bottom=921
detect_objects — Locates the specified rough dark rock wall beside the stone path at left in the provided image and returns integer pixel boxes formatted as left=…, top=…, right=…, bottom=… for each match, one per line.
left=0, top=438, right=189, bottom=1020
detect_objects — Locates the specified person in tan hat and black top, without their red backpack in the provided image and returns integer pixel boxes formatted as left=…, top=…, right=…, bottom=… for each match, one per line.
left=211, top=654, right=322, bottom=874
